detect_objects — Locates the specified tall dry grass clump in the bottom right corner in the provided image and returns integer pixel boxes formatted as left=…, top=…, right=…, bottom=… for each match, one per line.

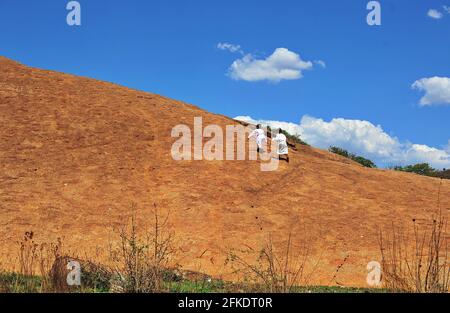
left=379, top=208, right=450, bottom=293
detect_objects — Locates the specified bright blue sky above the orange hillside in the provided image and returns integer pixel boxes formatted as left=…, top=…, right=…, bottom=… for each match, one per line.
left=0, top=0, right=450, bottom=167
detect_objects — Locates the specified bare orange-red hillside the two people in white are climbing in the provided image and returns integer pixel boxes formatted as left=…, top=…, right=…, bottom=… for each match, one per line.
left=0, top=57, right=450, bottom=286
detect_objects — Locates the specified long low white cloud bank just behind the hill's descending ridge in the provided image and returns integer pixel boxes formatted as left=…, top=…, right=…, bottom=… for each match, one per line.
left=235, top=116, right=450, bottom=168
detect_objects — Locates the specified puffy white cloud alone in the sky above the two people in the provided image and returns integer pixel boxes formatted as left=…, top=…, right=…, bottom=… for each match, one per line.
left=229, top=48, right=313, bottom=82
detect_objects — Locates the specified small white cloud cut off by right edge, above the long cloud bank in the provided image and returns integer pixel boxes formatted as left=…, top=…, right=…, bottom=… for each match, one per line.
left=411, top=76, right=450, bottom=106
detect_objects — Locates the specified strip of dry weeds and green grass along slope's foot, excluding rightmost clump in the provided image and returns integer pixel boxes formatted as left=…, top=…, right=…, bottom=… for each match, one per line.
left=0, top=217, right=386, bottom=293
